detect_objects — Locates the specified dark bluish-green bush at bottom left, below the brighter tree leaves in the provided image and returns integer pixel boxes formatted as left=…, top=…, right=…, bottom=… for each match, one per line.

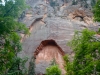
left=7, top=57, right=27, bottom=75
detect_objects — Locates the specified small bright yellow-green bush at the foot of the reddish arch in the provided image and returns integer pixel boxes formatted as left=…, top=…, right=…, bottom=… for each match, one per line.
left=46, top=65, right=61, bottom=75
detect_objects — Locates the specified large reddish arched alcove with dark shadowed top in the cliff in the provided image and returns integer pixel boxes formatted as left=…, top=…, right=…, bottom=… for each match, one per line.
left=34, top=39, right=65, bottom=74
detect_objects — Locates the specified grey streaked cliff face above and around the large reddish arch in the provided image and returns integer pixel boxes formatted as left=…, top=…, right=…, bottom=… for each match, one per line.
left=19, top=0, right=97, bottom=74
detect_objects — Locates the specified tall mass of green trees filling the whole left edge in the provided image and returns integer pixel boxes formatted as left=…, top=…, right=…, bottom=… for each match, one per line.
left=0, top=0, right=28, bottom=75
